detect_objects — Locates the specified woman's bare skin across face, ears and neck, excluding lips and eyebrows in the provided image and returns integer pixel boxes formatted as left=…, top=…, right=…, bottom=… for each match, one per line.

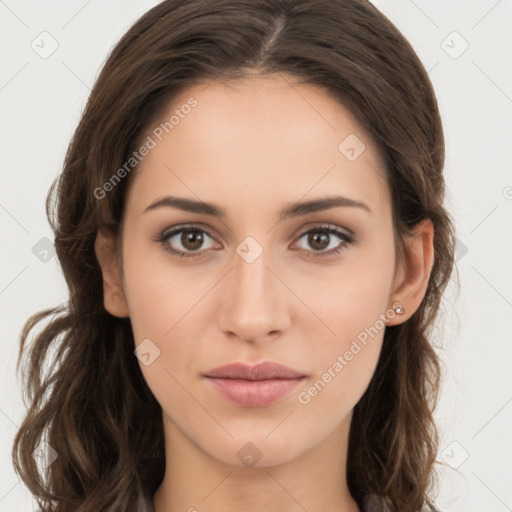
left=96, top=75, right=433, bottom=512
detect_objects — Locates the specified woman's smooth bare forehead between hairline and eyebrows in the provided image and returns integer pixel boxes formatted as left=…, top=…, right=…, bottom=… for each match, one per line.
left=126, top=74, right=389, bottom=217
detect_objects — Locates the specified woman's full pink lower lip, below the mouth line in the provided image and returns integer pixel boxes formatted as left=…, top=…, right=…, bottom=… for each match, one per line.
left=207, top=377, right=304, bottom=407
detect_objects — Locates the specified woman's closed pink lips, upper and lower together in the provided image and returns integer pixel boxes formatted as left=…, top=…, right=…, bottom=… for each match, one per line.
left=204, top=362, right=306, bottom=407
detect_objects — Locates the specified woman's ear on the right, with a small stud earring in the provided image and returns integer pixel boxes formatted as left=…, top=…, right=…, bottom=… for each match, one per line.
left=387, top=219, right=434, bottom=325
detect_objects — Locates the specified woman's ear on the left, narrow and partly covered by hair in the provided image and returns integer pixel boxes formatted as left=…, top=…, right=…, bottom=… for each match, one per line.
left=94, top=231, right=129, bottom=318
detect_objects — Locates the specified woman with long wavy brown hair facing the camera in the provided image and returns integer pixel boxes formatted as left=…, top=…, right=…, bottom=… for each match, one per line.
left=13, top=0, right=454, bottom=512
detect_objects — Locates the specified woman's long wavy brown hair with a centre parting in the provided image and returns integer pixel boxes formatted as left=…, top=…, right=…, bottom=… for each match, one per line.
left=12, top=0, right=454, bottom=512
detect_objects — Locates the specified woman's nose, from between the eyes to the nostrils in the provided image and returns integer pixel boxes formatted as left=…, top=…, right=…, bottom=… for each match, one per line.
left=218, top=244, right=292, bottom=342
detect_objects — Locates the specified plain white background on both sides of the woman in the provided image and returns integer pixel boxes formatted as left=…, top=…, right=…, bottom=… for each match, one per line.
left=0, top=0, right=512, bottom=512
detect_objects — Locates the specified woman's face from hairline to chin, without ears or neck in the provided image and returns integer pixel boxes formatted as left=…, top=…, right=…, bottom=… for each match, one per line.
left=106, top=76, right=396, bottom=466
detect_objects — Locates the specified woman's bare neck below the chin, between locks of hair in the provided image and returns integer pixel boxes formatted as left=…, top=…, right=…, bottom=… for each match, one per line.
left=153, top=414, right=359, bottom=512
